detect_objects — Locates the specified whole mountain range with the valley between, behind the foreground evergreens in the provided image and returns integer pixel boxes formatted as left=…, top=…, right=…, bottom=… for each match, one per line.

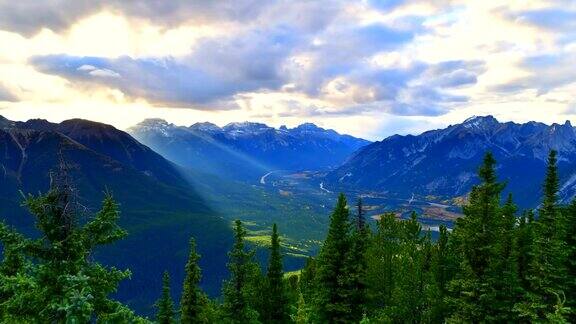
left=0, top=112, right=576, bottom=314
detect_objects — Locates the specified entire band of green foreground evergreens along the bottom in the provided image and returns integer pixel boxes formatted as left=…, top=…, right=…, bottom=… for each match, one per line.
left=0, top=151, right=576, bottom=324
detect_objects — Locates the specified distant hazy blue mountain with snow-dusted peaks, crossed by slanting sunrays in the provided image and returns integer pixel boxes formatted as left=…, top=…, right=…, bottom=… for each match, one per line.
left=129, top=119, right=369, bottom=181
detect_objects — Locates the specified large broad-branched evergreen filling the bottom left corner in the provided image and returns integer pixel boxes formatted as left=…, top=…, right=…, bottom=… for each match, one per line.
left=0, top=180, right=143, bottom=323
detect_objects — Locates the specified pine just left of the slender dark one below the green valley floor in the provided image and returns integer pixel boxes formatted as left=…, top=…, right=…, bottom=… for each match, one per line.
left=223, top=220, right=258, bottom=324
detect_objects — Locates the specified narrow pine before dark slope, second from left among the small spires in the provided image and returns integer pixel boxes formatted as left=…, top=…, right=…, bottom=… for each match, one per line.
left=180, top=238, right=209, bottom=324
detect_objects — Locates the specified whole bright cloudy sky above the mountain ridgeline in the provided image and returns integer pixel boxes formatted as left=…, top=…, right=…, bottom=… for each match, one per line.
left=0, top=0, right=576, bottom=139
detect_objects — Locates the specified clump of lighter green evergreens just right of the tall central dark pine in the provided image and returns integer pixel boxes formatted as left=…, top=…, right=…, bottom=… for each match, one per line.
left=366, top=213, right=444, bottom=323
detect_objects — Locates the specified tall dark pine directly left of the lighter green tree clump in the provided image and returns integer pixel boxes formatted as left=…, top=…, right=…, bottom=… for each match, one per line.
left=314, top=194, right=354, bottom=323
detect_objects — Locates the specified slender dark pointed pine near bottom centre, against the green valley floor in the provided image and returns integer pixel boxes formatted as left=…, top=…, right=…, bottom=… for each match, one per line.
left=262, top=224, right=289, bottom=323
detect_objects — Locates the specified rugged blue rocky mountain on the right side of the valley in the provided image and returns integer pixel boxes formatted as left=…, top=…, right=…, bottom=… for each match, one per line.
left=327, top=116, right=576, bottom=207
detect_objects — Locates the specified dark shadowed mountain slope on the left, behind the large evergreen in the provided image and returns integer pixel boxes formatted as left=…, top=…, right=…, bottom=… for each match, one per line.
left=0, top=117, right=231, bottom=314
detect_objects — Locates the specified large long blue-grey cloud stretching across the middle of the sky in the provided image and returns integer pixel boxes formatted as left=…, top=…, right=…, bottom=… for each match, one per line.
left=30, top=19, right=424, bottom=109
